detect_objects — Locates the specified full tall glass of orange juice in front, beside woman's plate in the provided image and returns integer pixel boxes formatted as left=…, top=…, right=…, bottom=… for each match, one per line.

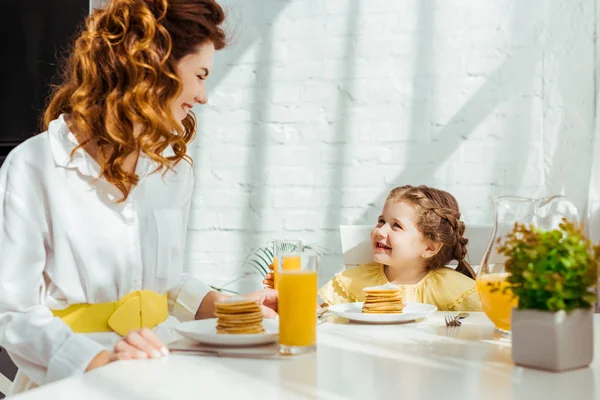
left=277, top=253, right=317, bottom=355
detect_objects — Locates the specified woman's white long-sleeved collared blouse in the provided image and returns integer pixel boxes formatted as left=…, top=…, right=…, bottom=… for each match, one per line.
left=0, top=116, right=210, bottom=384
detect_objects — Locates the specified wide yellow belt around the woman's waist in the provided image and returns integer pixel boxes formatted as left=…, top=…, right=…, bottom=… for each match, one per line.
left=52, top=290, right=169, bottom=336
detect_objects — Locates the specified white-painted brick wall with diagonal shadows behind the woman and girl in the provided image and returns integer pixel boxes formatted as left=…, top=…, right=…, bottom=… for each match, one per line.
left=188, top=0, right=595, bottom=290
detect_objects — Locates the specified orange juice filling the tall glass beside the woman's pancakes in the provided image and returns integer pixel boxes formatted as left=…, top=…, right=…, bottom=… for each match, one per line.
left=278, top=268, right=317, bottom=346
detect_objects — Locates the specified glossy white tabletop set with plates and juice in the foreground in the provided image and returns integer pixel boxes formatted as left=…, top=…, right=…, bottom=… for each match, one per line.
left=11, top=312, right=600, bottom=400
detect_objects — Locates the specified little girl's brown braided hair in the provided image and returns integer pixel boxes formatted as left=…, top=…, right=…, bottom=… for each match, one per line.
left=386, top=185, right=475, bottom=279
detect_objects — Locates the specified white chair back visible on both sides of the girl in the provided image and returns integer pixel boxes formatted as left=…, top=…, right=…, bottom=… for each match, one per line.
left=340, top=225, right=493, bottom=272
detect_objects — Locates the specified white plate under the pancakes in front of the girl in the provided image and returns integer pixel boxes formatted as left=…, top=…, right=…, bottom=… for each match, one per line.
left=329, top=302, right=437, bottom=323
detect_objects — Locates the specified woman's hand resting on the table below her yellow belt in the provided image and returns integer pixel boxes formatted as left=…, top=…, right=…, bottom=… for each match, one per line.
left=86, top=328, right=169, bottom=371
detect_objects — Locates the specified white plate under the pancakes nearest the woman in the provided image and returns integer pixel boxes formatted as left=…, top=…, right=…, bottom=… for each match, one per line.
left=175, top=318, right=279, bottom=346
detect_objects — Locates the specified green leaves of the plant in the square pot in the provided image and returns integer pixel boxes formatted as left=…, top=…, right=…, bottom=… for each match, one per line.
left=498, top=220, right=600, bottom=312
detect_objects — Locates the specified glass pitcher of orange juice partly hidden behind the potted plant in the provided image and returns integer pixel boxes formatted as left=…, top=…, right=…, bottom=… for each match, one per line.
left=476, top=196, right=579, bottom=339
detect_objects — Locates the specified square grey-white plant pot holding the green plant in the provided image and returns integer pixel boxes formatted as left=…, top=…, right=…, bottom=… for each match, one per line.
left=511, top=308, right=594, bottom=372
